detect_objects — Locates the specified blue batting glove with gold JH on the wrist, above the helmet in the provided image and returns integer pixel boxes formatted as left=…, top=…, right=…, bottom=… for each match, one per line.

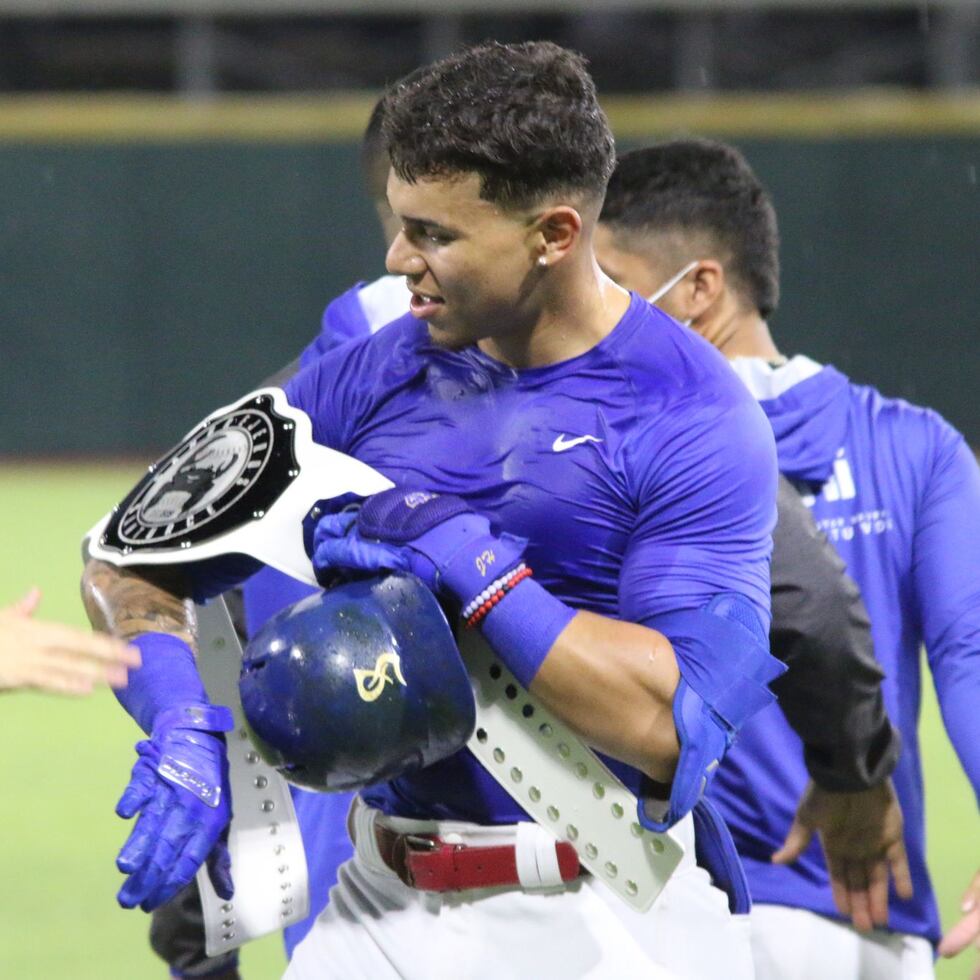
left=313, top=488, right=527, bottom=606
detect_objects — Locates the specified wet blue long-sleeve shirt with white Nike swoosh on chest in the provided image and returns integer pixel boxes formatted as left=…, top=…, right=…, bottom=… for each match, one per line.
left=286, top=295, right=776, bottom=824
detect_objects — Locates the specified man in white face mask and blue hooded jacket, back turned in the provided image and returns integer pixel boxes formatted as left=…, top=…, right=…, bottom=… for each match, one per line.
left=597, top=140, right=980, bottom=980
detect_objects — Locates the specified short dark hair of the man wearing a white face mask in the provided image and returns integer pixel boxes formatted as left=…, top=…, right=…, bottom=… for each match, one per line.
left=599, top=139, right=779, bottom=317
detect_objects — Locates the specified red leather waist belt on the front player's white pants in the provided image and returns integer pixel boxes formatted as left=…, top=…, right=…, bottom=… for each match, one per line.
left=374, top=824, right=581, bottom=892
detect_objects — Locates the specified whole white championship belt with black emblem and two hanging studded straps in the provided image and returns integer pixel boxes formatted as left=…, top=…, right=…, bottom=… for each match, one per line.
left=87, top=388, right=684, bottom=955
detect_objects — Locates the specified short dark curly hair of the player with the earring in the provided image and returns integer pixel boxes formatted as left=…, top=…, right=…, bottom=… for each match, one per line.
left=382, top=41, right=615, bottom=208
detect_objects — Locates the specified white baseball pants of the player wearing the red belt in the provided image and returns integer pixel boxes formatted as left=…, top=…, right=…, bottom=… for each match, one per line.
left=285, top=804, right=753, bottom=980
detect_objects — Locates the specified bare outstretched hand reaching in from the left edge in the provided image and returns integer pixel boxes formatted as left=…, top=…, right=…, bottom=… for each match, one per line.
left=0, top=589, right=140, bottom=696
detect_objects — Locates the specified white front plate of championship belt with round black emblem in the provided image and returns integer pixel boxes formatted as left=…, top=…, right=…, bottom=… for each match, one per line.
left=88, top=388, right=392, bottom=585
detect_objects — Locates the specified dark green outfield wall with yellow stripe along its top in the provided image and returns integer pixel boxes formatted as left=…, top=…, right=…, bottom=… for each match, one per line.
left=0, top=95, right=980, bottom=455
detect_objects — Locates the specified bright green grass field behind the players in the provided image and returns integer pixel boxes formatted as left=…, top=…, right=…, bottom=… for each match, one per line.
left=0, top=463, right=980, bottom=980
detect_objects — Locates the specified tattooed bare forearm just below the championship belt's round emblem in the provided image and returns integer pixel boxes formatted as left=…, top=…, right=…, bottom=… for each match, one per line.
left=82, top=559, right=197, bottom=646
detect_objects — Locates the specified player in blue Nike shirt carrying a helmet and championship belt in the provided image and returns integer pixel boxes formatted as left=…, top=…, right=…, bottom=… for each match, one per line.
left=85, top=43, right=781, bottom=978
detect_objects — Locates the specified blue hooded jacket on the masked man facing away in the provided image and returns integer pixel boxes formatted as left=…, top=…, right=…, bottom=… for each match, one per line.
left=711, top=358, right=980, bottom=942
